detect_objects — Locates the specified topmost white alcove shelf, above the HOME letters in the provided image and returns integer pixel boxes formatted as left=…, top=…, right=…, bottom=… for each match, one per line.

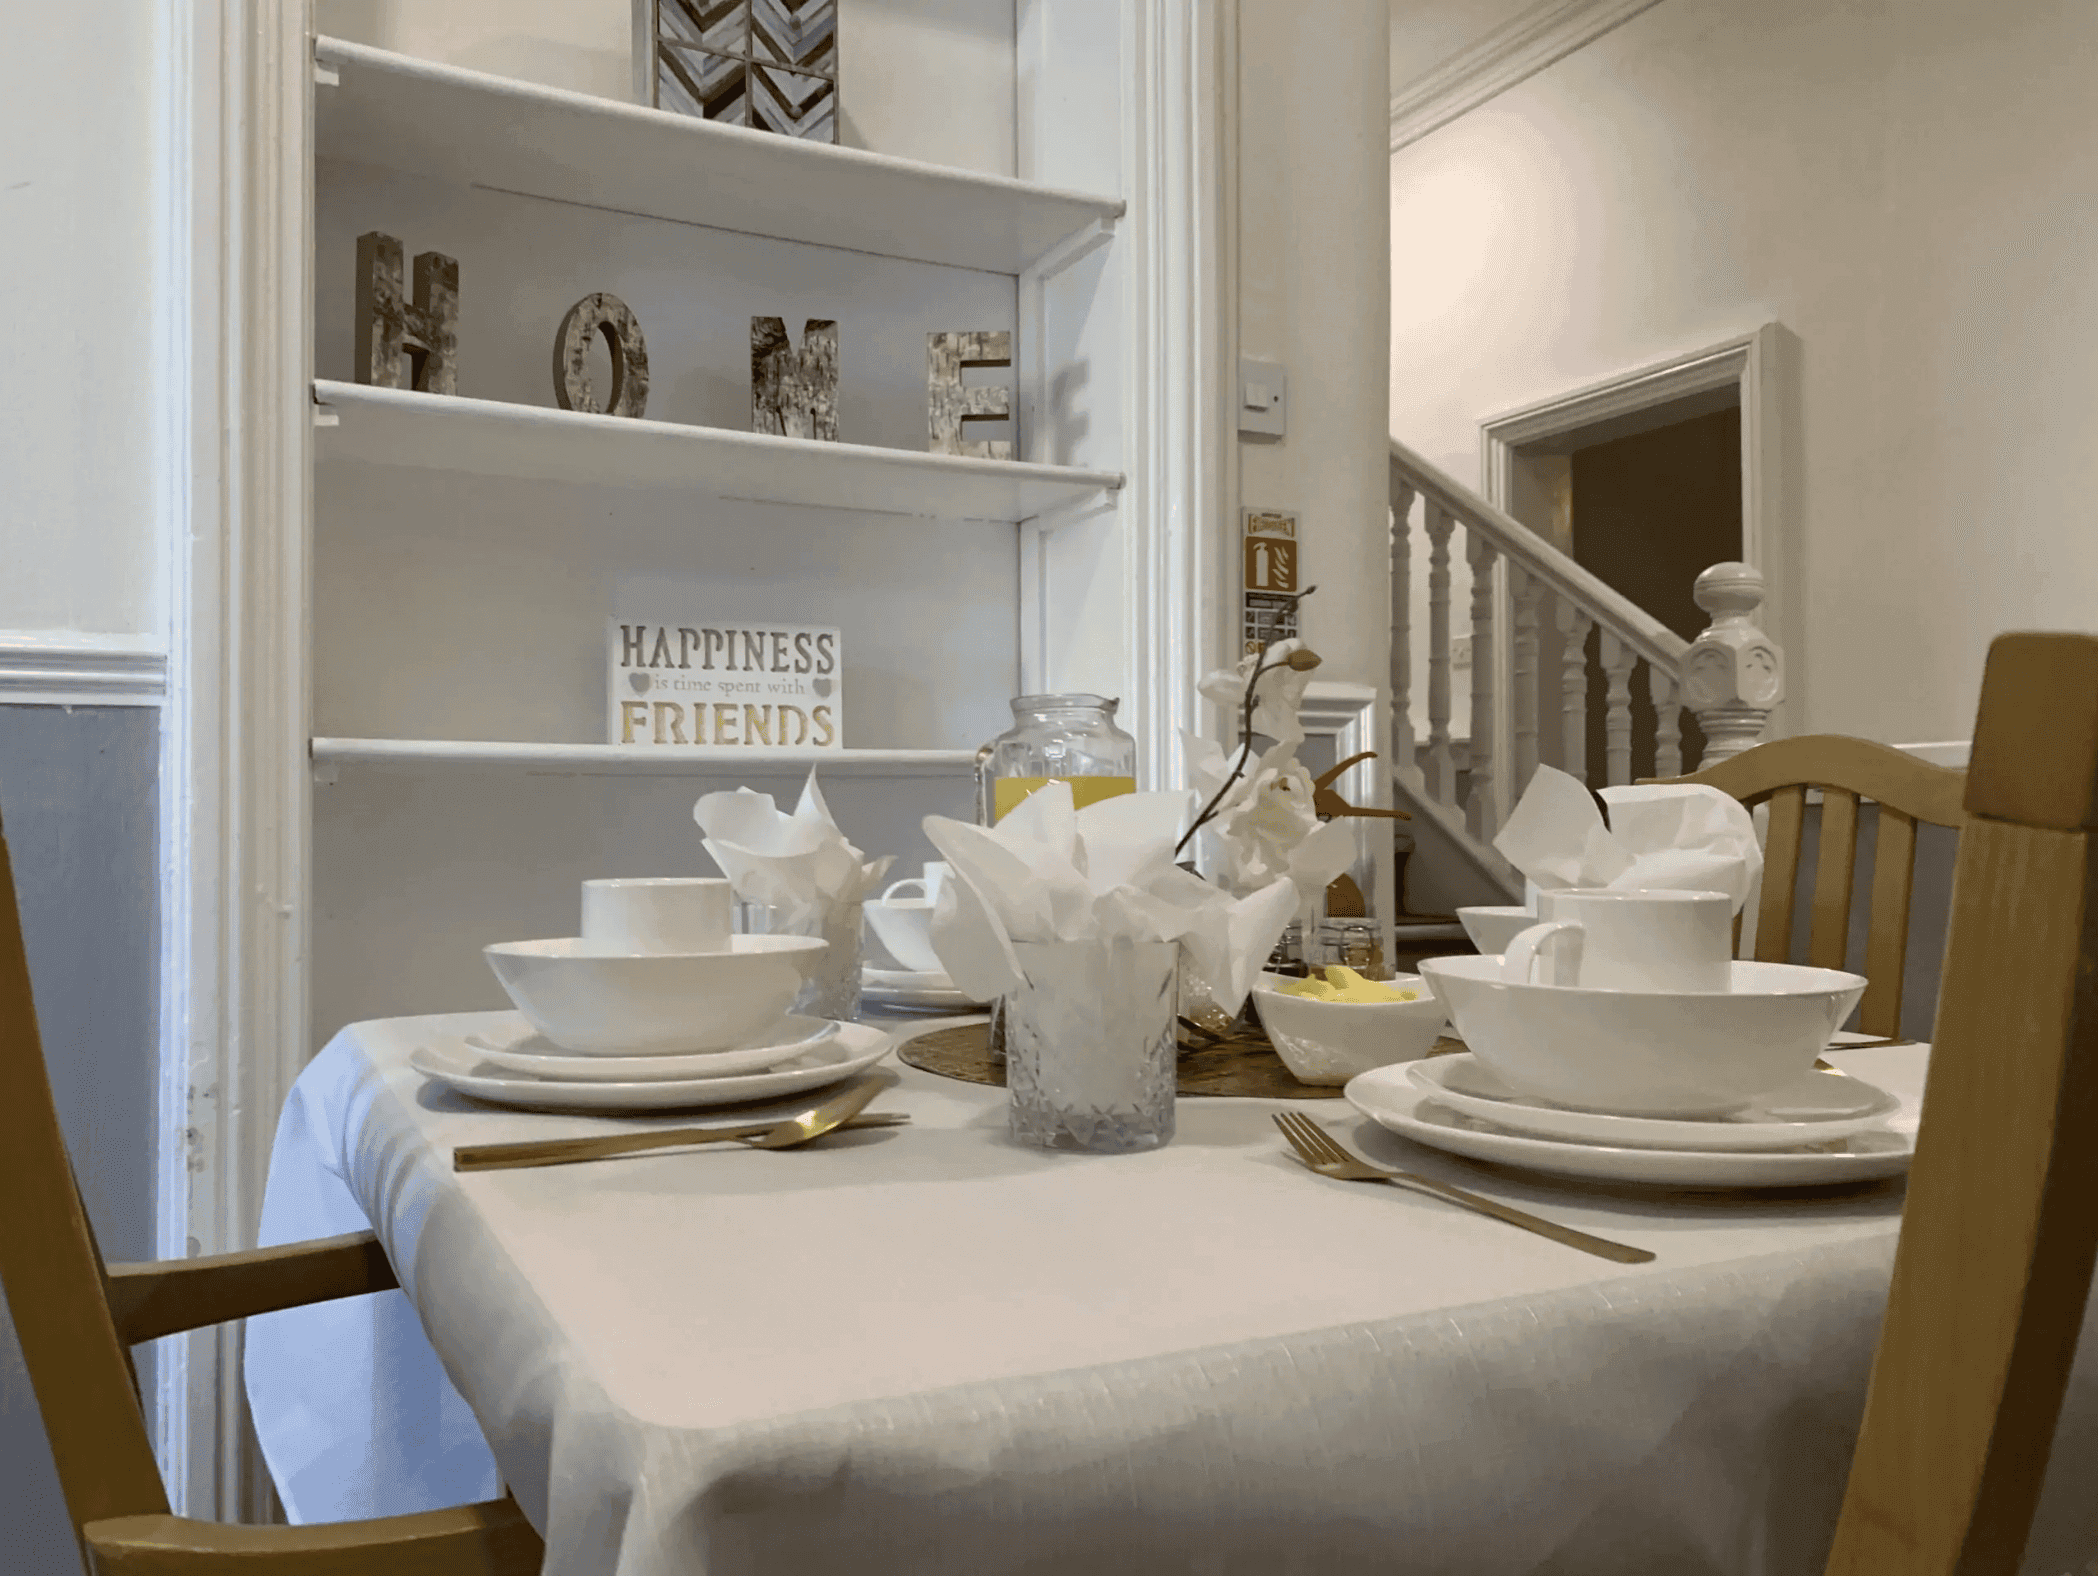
left=313, top=38, right=1125, bottom=273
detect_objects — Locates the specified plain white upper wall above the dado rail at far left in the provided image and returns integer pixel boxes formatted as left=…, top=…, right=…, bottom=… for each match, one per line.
left=0, top=0, right=162, bottom=646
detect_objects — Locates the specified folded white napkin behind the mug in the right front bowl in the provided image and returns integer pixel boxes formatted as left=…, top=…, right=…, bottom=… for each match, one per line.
left=1494, top=766, right=1762, bottom=913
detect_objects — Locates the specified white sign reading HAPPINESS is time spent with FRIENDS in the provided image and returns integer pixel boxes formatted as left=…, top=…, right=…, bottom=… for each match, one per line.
left=606, top=619, right=845, bottom=749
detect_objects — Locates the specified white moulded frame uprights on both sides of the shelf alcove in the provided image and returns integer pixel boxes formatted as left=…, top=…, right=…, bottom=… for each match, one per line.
left=155, top=0, right=1236, bottom=1519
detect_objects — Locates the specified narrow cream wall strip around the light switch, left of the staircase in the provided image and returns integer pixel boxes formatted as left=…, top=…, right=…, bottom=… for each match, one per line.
left=1229, top=0, right=1391, bottom=686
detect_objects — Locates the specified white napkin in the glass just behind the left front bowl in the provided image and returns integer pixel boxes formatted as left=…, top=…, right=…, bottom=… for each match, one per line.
left=692, top=768, right=894, bottom=923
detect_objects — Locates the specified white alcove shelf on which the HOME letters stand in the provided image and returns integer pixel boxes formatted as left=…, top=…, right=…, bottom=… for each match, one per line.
left=313, top=380, right=1122, bottom=523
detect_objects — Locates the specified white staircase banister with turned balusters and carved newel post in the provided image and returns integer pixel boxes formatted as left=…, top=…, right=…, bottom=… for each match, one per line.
left=1391, top=441, right=1783, bottom=913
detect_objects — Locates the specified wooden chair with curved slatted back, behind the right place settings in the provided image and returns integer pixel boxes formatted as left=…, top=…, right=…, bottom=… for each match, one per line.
left=1666, top=734, right=1966, bottom=1037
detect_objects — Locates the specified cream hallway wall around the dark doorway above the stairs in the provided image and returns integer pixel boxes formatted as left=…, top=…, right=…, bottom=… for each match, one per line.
left=1391, top=0, right=2098, bottom=741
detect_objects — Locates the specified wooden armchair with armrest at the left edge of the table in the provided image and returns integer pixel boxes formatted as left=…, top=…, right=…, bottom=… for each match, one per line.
left=0, top=814, right=541, bottom=1576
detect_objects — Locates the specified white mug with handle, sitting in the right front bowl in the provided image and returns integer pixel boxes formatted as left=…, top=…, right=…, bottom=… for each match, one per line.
left=1502, top=888, right=1733, bottom=993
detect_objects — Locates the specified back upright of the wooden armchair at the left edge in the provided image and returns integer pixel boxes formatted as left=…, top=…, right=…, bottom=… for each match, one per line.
left=0, top=805, right=168, bottom=1532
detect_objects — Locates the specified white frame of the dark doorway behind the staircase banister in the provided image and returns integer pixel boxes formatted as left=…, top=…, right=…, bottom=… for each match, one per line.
left=1479, top=323, right=1804, bottom=760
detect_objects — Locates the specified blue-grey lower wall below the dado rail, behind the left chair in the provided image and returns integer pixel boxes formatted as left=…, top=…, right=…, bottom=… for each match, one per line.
left=0, top=705, right=159, bottom=1576
